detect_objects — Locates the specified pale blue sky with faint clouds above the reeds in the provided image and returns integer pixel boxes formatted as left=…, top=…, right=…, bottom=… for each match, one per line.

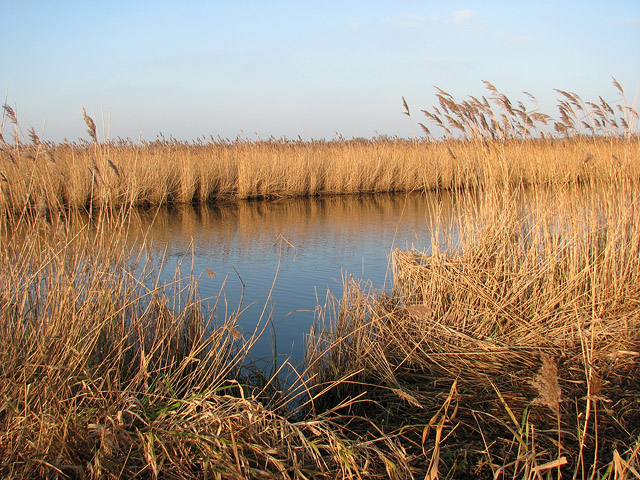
left=0, top=0, right=640, bottom=141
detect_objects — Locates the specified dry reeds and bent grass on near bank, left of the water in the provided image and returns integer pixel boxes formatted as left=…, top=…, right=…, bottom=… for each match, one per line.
left=0, top=212, right=410, bottom=479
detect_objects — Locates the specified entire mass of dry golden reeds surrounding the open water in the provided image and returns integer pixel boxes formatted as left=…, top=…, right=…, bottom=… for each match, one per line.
left=0, top=81, right=640, bottom=479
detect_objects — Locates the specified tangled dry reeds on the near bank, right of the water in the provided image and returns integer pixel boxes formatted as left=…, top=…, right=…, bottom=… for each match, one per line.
left=308, top=183, right=640, bottom=478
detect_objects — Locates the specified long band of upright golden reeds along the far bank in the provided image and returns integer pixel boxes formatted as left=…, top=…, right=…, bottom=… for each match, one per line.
left=0, top=80, right=640, bottom=216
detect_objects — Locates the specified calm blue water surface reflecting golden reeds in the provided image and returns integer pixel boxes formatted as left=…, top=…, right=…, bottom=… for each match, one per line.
left=133, top=194, right=460, bottom=360
